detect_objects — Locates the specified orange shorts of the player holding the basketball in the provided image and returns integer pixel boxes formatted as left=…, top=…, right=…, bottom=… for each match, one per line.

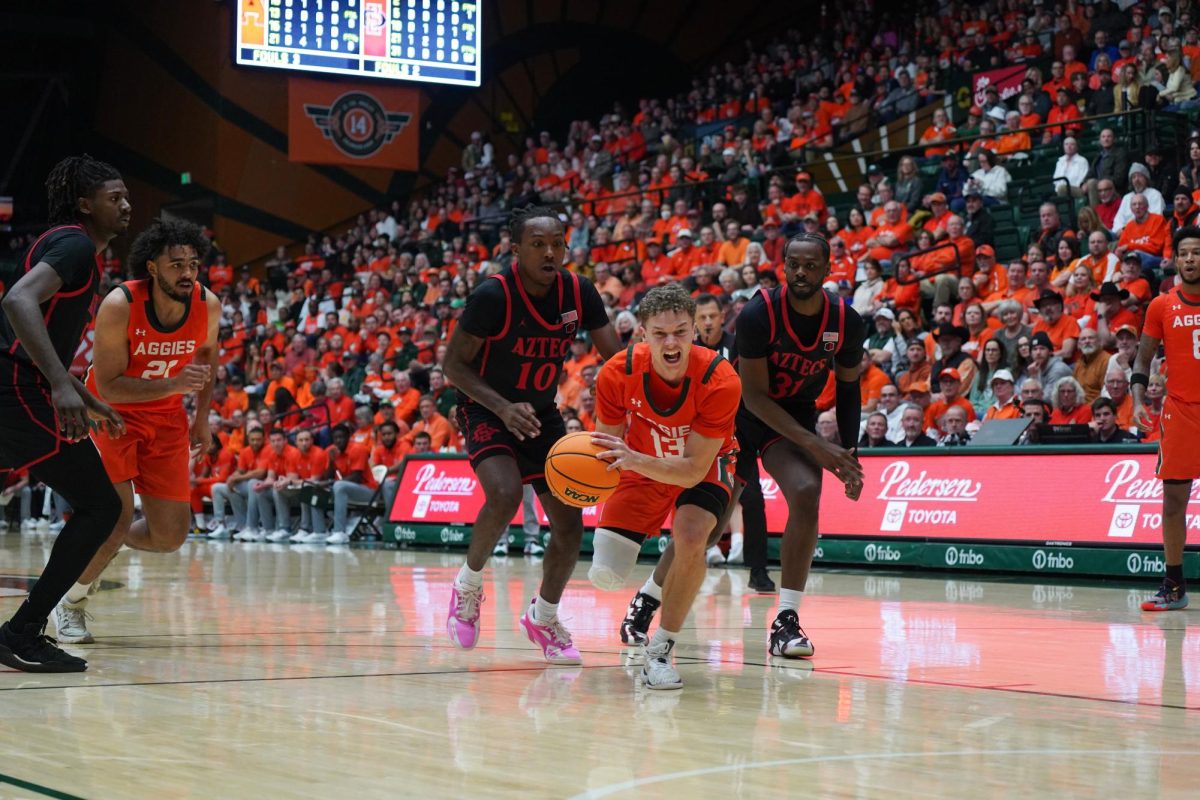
left=598, top=455, right=733, bottom=536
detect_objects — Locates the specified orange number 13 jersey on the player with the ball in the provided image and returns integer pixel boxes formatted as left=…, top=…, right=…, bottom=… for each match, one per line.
left=596, top=342, right=742, bottom=458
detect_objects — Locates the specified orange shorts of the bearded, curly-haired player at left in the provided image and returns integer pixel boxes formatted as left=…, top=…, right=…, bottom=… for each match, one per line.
left=91, top=408, right=192, bottom=503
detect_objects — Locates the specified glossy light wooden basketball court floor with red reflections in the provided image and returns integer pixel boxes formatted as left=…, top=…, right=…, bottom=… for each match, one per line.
left=0, top=533, right=1200, bottom=800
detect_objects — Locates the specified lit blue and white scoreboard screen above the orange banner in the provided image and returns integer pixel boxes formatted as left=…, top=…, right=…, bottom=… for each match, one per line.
left=235, top=0, right=480, bottom=86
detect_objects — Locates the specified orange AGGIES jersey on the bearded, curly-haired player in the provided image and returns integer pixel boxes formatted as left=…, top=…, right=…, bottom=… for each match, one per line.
left=84, top=281, right=209, bottom=413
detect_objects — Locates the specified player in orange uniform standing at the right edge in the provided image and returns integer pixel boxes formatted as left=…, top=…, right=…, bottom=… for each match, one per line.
left=1129, top=225, right=1200, bottom=612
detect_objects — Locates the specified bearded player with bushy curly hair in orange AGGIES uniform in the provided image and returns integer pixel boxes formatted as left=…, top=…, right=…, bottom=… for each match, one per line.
left=54, top=219, right=221, bottom=644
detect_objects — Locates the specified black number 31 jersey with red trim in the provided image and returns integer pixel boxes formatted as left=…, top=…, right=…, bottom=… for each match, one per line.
left=737, top=287, right=866, bottom=420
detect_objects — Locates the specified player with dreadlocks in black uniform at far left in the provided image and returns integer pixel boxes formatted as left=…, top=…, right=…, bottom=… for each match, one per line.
left=0, top=156, right=131, bottom=672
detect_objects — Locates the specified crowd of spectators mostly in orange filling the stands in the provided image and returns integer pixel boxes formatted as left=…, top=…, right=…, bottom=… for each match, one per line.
left=9, top=0, right=1200, bottom=541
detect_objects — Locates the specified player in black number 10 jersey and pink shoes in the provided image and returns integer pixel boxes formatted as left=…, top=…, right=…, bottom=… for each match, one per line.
left=445, top=207, right=622, bottom=663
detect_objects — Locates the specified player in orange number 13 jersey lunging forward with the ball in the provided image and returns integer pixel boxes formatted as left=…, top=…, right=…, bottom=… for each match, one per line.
left=588, top=283, right=742, bottom=688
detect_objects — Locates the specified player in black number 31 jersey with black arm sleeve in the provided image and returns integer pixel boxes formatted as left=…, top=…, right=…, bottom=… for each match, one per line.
left=737, top=234, right=866, bottom=658
